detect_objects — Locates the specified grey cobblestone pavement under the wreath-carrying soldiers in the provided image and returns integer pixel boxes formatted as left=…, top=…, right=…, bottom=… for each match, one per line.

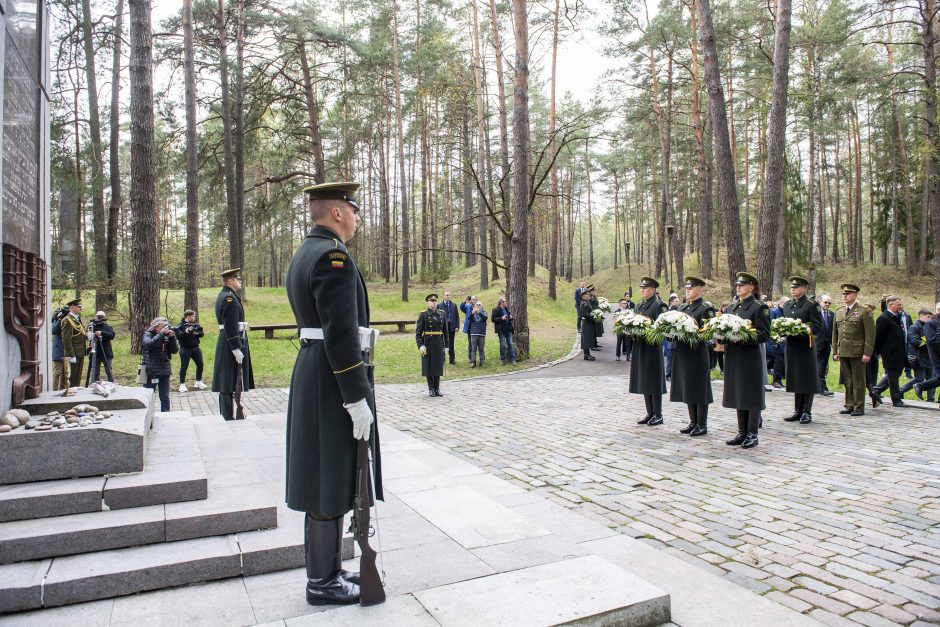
left=173, top=357, right=940, bottom=625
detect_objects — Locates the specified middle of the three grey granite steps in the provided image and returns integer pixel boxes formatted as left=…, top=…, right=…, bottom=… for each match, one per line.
left=0, top=485, right=277, bottom=564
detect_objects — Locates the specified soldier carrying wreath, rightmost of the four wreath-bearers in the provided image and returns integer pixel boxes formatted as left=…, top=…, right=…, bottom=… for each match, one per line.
left=783, top=276, right=823, bottom=425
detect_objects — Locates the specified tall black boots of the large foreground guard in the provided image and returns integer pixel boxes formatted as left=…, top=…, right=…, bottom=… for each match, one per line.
left=304, top=514, right=359, bottom=605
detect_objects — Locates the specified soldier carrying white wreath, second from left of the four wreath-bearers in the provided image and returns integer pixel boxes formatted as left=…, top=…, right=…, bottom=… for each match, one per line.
left=669, top=276, right=715, bottom=436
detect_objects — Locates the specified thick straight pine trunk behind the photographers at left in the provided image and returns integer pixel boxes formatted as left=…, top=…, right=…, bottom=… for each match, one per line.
left=129, top=0, right=160, bottom=354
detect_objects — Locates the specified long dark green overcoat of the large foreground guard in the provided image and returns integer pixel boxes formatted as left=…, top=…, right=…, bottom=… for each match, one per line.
left=287, top=226, right=383, bottom=517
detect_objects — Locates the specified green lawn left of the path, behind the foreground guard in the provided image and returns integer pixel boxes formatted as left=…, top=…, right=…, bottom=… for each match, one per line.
left=52, top=268, right=575, bottom=387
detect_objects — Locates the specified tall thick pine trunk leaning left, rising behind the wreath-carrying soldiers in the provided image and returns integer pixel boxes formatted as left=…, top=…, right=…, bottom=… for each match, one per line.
left=697, top=0, right=746, bottom=282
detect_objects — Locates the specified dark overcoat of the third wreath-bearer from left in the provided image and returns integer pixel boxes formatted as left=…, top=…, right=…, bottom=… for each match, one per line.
left=721, top=296, right=770, bottom=410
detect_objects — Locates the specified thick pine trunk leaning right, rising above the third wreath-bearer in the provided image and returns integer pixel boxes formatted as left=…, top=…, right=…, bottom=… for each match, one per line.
left=757, top=0, right=791, bottom=294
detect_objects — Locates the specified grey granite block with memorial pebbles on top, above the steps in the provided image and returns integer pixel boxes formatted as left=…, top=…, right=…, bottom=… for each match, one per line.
left=0, top=388, right=153, bottom=485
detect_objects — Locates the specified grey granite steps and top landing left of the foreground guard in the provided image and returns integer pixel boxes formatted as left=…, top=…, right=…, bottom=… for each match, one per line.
left=0, top=398, right=322, bottom=613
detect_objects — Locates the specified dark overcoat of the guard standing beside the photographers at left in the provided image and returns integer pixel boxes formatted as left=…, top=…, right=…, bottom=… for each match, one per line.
left=212, top=287, right=255, bottom=394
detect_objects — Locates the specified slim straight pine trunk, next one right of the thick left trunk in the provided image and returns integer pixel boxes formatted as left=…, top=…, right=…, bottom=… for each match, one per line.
left=183, top=0, right=200, bottom=311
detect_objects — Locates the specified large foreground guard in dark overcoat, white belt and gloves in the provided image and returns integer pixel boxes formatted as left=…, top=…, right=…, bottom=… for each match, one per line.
left=286, top=183, right=383, bottom=604
